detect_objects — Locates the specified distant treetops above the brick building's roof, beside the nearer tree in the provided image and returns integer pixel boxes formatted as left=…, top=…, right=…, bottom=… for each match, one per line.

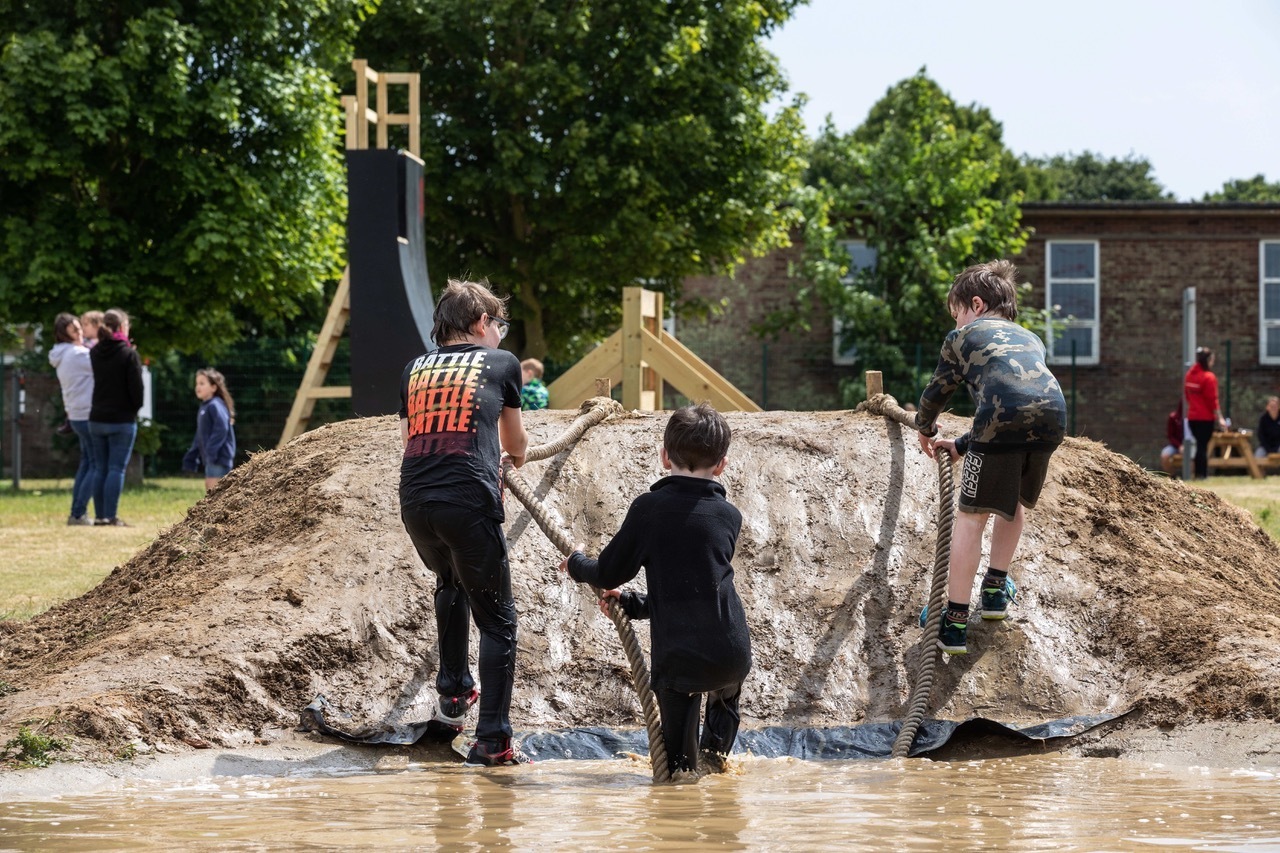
left=1023, top=151, right=1174, bottom=201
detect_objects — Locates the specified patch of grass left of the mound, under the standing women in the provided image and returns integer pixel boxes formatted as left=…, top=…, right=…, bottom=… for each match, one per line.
left=0, top=478, right=205, bottom=619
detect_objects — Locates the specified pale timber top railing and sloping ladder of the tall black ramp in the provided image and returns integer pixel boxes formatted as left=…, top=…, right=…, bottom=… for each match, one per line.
left=278, top=59, right=421, bottom=447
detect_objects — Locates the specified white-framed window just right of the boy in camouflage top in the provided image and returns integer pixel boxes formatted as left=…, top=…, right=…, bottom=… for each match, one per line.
left=1044, top=240, right=1100, bottom=364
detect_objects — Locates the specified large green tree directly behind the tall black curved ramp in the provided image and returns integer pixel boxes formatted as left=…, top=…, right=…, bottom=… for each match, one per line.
left=357, top=0, right=804, bottom=359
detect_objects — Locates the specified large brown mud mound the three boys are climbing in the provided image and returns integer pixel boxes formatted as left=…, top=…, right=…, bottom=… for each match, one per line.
left=0, top=411, right=1280, bottom=756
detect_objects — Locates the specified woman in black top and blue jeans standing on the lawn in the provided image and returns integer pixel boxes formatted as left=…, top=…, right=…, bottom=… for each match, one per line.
left=88, top=309, right=143, bottom=528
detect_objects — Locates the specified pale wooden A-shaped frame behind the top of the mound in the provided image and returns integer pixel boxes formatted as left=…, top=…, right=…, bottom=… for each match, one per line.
left=547, top=287, right=760, bottom=411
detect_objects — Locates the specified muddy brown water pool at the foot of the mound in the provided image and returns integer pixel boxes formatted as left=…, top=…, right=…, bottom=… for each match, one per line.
left=0, top=754, right=1280, bottom=850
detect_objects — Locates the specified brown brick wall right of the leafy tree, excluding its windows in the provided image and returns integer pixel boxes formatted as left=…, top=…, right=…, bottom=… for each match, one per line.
left=1012, top=205, right=1280, bottom=467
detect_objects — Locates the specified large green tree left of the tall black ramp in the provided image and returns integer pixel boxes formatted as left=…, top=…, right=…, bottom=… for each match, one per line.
left=0, top=0, right=369, bottom=353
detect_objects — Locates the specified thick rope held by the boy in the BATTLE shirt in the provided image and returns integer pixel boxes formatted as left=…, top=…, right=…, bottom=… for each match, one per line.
left=503, top=397, right=671, bottom=783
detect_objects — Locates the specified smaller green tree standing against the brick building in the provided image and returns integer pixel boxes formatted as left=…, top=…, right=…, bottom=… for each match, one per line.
left=762, top=69, right=1027, bottom=402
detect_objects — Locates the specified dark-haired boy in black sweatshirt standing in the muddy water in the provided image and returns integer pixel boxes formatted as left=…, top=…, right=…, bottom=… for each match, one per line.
left=561, top=403, right=751, bottom=772
